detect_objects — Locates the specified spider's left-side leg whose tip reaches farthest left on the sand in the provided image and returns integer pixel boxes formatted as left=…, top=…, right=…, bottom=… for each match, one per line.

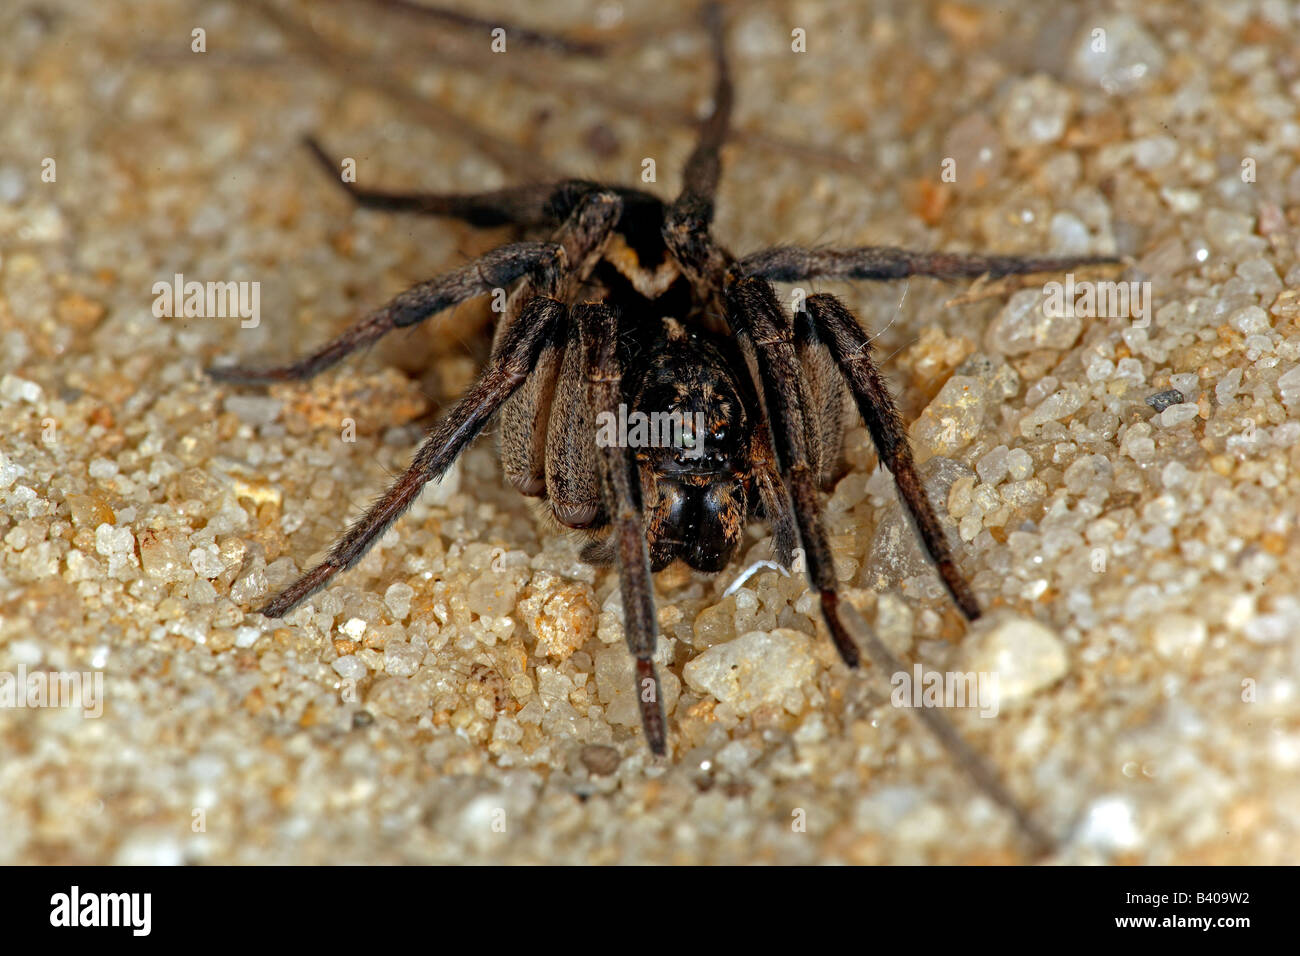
left=208, top=242, right=563, bottom=385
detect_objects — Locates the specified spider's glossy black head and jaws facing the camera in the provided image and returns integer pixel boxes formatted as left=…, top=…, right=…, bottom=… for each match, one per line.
left=631, top=320, right=750, bottom=572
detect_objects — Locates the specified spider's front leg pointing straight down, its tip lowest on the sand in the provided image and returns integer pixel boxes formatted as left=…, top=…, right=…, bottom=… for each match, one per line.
left=573, top=304, right=668, bottom=757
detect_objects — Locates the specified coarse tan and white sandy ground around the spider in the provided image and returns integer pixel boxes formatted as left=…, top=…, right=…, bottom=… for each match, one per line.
left=0, top=0, right=1300, bottom=864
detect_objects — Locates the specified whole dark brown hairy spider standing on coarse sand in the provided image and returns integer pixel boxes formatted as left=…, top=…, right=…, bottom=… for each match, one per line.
left=209, top=5, right=1114, bottom=837
